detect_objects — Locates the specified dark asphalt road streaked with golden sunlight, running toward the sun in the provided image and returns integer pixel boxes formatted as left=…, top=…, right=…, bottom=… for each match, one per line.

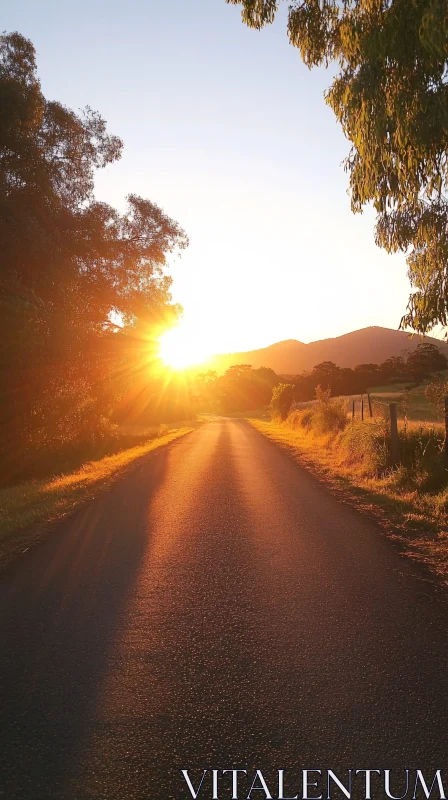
left=0, top=419, right=448, bottom=800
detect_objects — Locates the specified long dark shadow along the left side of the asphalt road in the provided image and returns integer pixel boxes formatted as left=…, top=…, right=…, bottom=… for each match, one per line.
left=0, top=443, right=173, bottom=800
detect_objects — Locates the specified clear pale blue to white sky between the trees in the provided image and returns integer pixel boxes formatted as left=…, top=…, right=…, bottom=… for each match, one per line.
left=2, top=0, right=416, bottom=352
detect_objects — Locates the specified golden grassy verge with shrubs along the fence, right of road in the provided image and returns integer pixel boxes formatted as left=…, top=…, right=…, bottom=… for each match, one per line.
left=248, top=411, right=448, bottom=583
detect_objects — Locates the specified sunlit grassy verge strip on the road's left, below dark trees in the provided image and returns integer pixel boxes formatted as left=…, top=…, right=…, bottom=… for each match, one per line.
left=0, top=423, right=195, bottom=565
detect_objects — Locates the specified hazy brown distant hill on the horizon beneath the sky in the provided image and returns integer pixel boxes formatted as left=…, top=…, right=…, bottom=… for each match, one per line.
left=207, top=326, right=448, bottom=375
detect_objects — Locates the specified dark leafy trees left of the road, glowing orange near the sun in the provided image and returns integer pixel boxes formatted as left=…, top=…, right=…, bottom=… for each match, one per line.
left=0, top=33, right=187, bottom=482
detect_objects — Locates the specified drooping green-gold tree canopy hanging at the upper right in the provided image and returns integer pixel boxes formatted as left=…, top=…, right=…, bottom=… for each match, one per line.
left=226, top=0, right=448, bottom=332
